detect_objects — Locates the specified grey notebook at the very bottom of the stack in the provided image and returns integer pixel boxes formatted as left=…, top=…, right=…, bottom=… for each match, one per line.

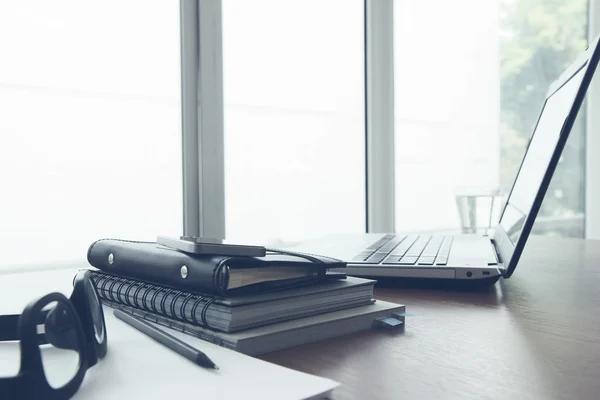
left=110, top=300, right=405, bottom=356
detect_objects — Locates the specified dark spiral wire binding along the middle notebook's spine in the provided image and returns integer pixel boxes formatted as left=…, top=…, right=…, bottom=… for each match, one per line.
left=92, top=271, right=215, bottom=329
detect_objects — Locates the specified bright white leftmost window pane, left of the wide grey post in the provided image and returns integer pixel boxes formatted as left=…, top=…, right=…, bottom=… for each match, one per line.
left=0, top=0, right=182, bottom=267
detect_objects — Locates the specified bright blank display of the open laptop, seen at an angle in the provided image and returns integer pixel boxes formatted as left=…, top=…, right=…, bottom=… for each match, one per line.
left=500, top=68, right=585, bottom=245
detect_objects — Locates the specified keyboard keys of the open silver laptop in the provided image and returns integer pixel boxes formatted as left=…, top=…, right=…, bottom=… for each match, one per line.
left=351, top=234, right=453, bottom=266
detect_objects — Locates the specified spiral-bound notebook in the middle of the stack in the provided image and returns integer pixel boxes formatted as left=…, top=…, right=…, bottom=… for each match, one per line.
left=92, top=270, right=376, bottom=332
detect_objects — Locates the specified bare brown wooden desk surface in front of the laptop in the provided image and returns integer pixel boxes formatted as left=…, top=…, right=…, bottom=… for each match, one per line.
left=262, top=237, right=600, bottom=400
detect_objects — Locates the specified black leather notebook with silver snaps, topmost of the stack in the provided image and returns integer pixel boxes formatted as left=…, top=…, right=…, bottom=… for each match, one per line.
left=87, top=239, right=346, bottom=296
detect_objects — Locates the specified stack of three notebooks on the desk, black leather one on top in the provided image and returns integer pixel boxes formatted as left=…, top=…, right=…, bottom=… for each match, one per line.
left=88, top=239, right=405, bottom=355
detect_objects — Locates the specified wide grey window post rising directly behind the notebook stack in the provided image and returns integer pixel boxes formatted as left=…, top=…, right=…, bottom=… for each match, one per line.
left=180, top=0, right=225, bottom=239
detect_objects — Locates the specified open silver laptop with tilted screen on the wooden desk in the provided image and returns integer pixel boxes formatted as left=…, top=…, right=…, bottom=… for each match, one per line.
left=284, top=33, right=600, bottom=285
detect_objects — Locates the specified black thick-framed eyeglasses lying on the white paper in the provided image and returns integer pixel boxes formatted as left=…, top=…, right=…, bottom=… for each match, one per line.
left=0, top=271, right=107, bottom=400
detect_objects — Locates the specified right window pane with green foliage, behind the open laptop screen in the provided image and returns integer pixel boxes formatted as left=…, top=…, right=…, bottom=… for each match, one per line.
left=394, top=0, right=587, bottom=236
